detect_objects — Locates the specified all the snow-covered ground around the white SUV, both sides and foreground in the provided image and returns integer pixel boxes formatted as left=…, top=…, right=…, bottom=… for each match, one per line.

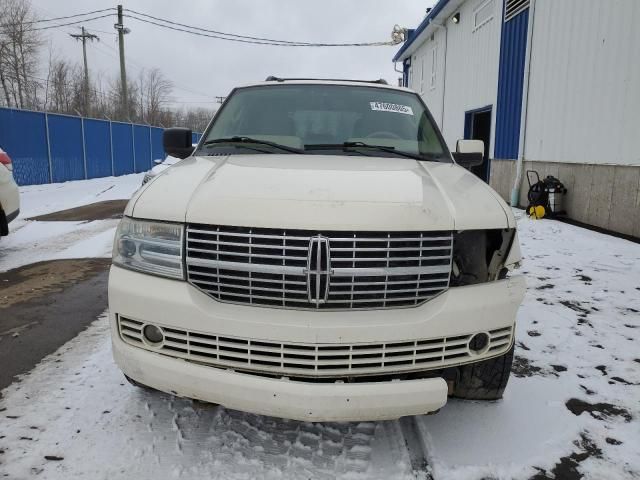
left=0, top=176, right=640, bottom=480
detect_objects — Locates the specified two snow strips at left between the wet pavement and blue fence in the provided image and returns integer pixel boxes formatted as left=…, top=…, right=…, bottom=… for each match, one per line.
left=0, top=174, right=143, bottom=271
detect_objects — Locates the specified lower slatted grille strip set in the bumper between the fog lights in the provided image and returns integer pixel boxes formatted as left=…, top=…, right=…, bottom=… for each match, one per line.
left=118, top=316, right=513, bottom=377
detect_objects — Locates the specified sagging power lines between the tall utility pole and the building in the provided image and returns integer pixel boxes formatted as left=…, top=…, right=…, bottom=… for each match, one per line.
left=125, top=10, right=396, bottom=47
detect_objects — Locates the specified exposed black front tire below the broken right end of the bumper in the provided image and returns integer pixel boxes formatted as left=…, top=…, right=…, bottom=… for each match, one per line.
left=453, top=345, right=514, bottom=400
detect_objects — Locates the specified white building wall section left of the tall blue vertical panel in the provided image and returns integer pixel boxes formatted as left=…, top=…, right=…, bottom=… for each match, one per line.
left=409, top=0, right=502, bottom=152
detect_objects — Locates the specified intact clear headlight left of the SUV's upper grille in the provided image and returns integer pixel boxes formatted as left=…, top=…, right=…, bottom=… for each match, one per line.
left=113, top=217, right=184, bottom=280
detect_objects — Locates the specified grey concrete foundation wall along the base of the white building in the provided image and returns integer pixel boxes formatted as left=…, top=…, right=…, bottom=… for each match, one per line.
left=490, top=160, right=640, bottom=238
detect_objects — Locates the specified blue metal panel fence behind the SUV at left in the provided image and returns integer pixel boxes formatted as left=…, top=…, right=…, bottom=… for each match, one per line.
left=0, top=108, right=201, bottom=185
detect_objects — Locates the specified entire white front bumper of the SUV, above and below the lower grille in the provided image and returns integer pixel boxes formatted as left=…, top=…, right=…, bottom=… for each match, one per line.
left=109, top=267, right=525, bottom=421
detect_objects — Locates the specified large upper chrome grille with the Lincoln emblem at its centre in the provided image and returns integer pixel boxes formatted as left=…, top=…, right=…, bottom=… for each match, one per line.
left=186, top=225, right=453, bottom=310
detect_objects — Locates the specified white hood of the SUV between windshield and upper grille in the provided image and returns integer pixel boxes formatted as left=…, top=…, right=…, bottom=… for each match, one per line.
left=130, top=154, right=515, bottom=230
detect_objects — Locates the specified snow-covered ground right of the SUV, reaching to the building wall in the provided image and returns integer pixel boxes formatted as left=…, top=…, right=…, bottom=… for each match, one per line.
left=420, top=212, right=640, bottom=480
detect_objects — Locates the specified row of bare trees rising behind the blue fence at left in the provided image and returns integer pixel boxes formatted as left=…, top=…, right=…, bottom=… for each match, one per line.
left=0, top=0, right=213, bottom=131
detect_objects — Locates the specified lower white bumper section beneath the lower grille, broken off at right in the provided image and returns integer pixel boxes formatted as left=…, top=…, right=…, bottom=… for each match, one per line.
left=113, top=339, right=447, bottom=422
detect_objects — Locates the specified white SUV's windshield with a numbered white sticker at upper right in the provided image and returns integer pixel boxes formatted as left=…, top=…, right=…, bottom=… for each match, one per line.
left=200, top=84, right=450, bottom=162
